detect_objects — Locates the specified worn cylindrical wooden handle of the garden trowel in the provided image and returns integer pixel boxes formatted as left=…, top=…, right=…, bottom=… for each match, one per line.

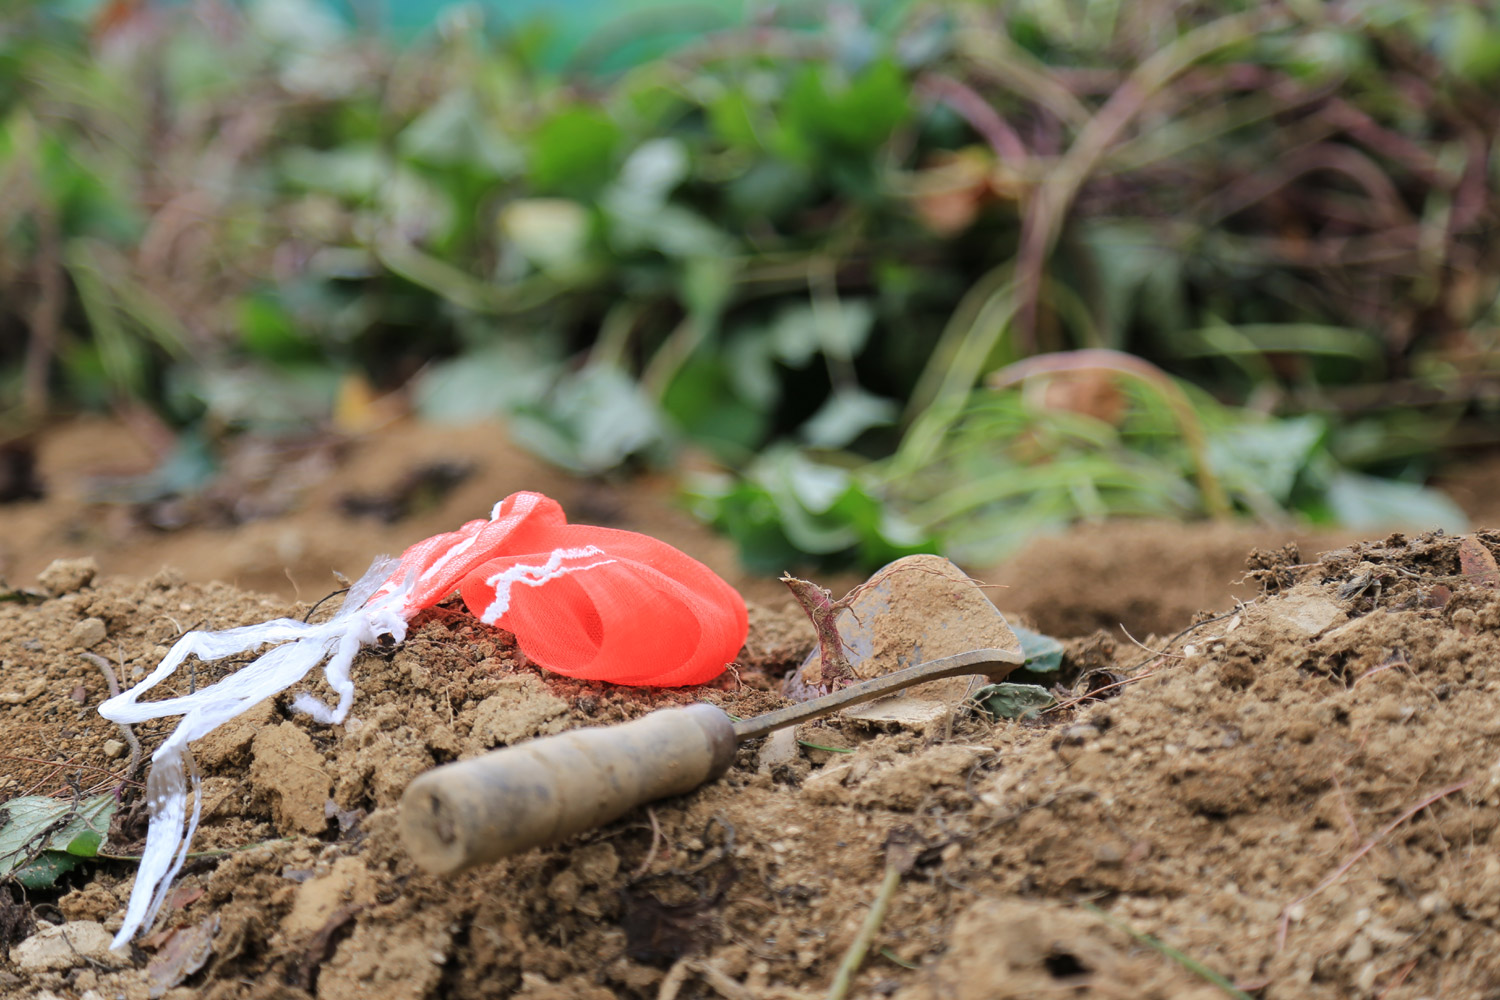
left=401, top=705, right=735, bottom=874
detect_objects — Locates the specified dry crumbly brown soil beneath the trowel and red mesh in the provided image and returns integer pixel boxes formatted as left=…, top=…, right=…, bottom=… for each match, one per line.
left=0, top=427, right=1500, bottom=1000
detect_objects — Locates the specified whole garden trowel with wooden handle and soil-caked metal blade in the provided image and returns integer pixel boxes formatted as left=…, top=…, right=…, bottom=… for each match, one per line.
left=401, top=556, right=1025, bottom=874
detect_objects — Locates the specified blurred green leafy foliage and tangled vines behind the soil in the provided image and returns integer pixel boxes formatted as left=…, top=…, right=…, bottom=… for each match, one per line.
left=0, top=0, right=1500, bottom=568
